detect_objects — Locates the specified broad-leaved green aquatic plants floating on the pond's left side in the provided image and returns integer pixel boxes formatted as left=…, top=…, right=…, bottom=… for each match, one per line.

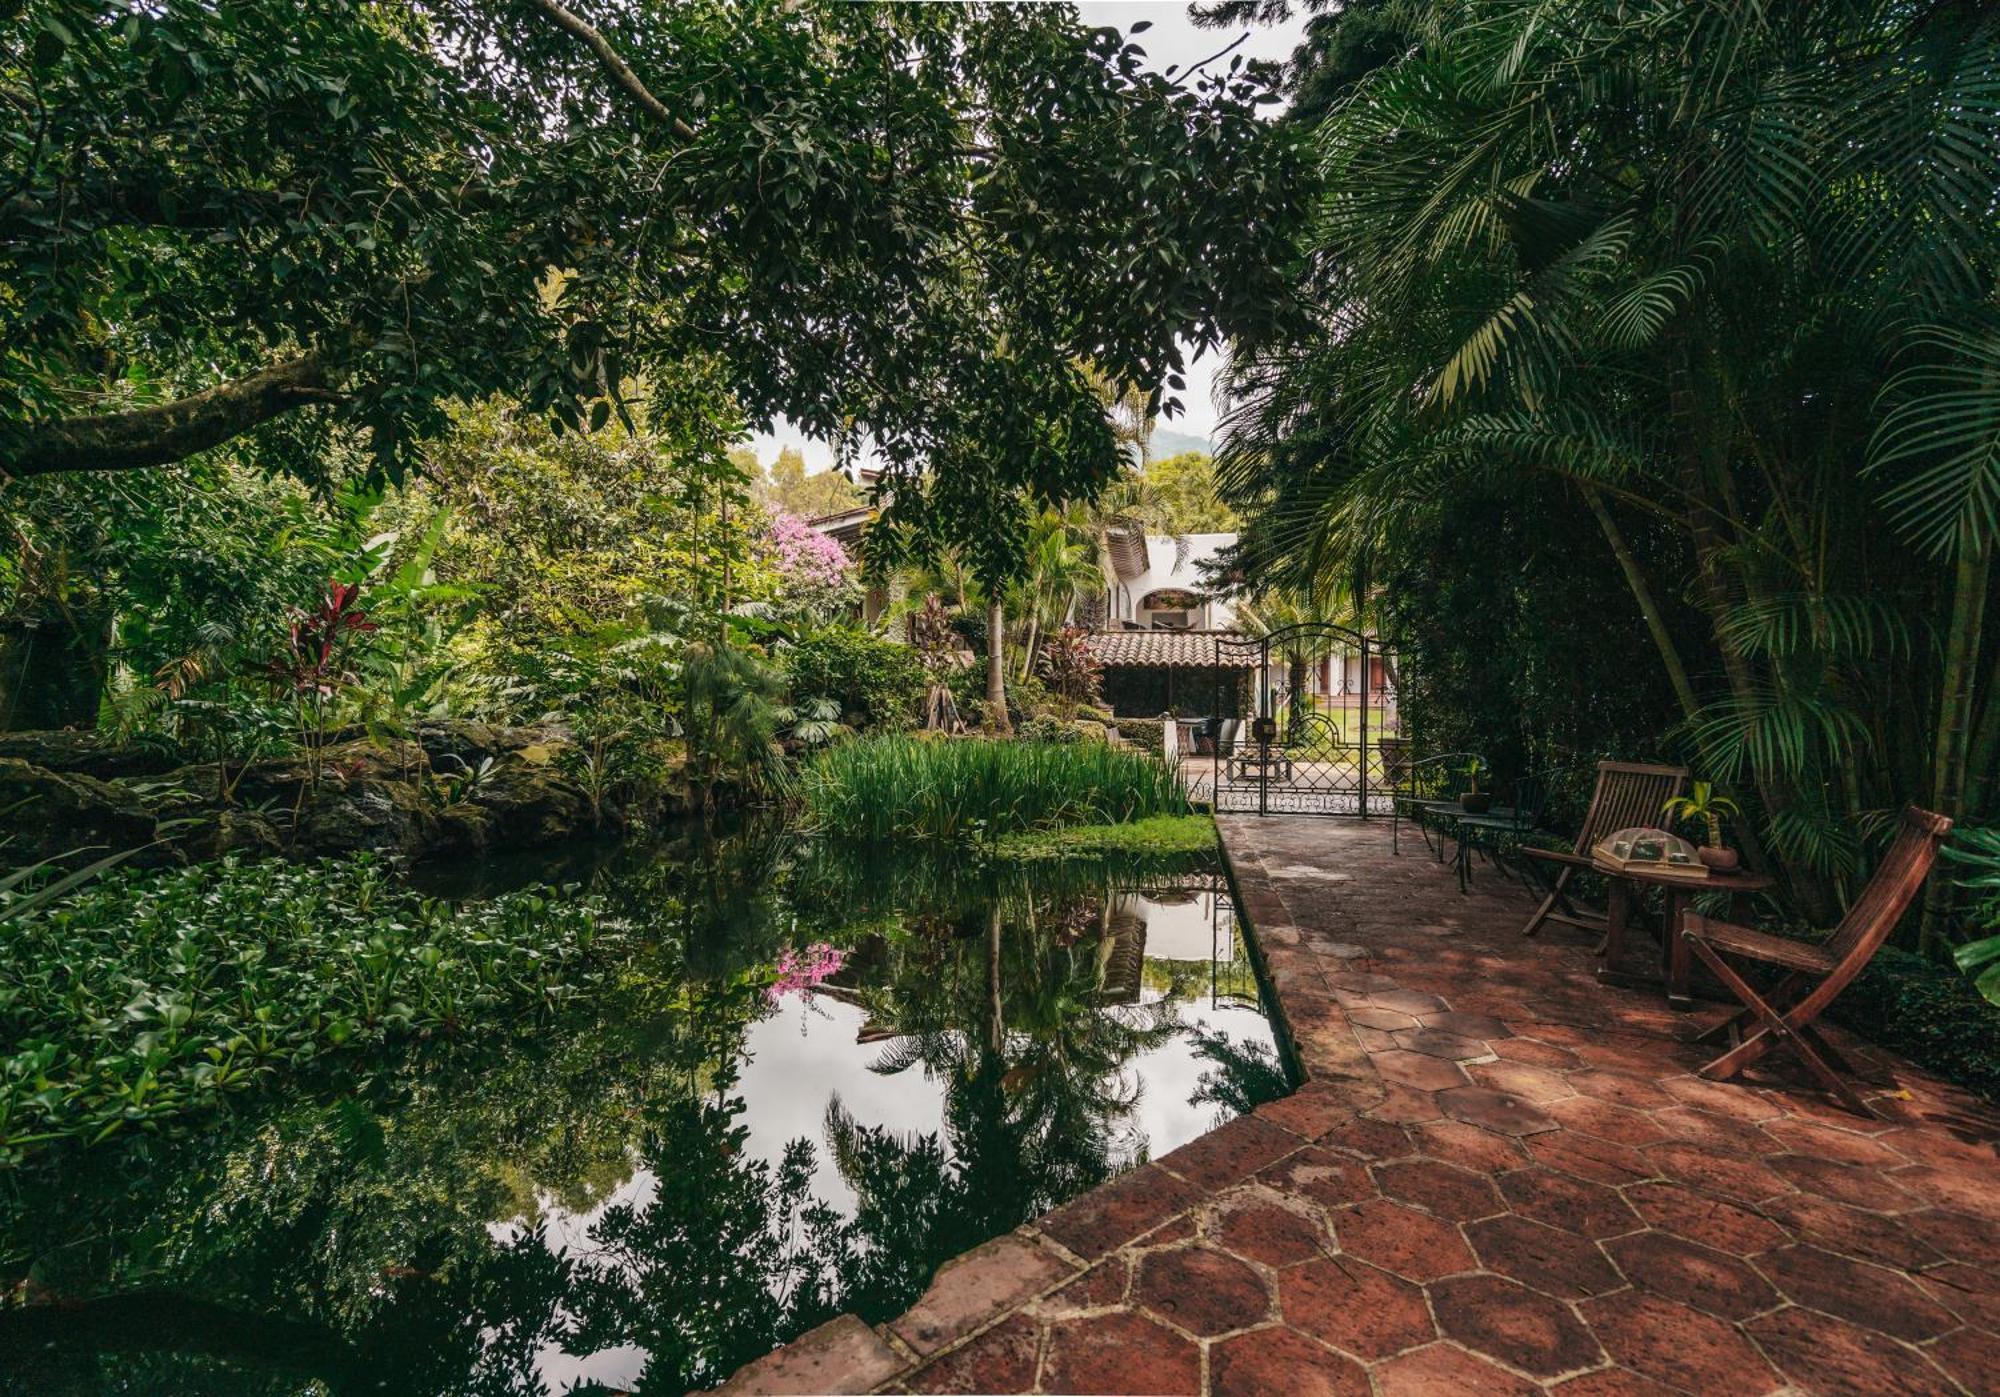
left=0, top=855, right=620, bottom=1165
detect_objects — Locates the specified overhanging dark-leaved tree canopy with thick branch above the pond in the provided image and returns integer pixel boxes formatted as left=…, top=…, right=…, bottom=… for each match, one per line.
left=0, top=0, right=1304, bottom=564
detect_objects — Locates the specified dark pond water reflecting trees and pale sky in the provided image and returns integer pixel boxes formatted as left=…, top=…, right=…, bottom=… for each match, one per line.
left=0, top=829, right=1286, bottom=1393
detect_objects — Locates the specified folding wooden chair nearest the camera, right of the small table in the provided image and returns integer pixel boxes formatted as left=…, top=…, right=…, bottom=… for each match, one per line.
left=1680, top=805, right=1952, bottom=1117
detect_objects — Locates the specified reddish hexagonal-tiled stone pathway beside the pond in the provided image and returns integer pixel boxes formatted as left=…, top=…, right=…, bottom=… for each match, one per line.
left=722, top=817, right=2000, bottom=1397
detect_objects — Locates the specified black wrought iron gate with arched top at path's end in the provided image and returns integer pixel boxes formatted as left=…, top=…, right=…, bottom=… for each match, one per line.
left=1192, top=620, right=1402, bottom=819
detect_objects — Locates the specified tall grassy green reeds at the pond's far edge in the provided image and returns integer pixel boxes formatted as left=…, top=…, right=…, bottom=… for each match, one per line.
left=802, top=735, right=1188, bottom=841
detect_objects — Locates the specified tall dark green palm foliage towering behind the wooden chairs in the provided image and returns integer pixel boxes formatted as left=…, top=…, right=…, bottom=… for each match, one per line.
left=1220, top=0, right=2000, bottom=935
